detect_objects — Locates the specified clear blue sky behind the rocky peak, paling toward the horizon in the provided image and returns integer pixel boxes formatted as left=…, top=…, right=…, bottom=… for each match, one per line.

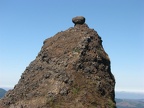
left=0, top=0, right=144, bottom=92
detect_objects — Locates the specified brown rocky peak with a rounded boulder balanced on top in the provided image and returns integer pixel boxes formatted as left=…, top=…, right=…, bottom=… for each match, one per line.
left=0, top=16, right=116, bottom=108
